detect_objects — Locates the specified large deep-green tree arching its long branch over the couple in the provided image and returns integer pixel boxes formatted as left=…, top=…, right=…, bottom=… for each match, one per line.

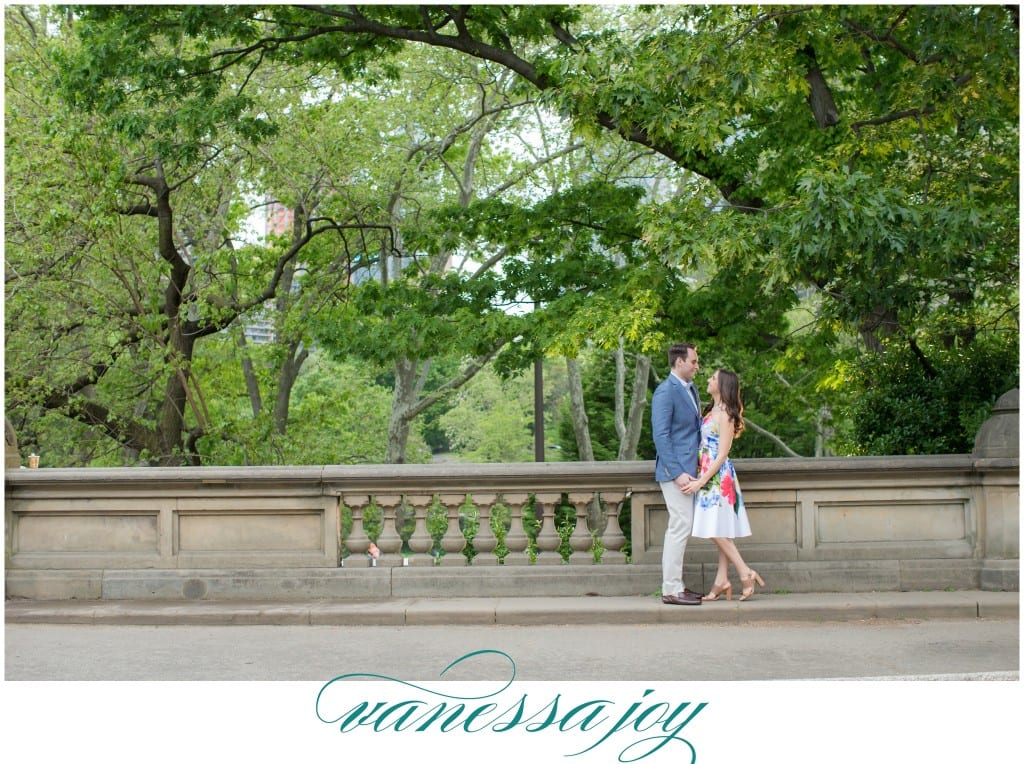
left=14, top=5, right=1019, bottom=453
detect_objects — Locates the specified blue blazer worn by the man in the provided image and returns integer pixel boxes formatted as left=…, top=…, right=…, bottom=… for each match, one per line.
left=650, top=374, right=700, bottom=482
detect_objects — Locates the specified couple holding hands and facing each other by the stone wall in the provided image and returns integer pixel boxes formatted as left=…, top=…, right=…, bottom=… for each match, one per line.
left=650, top=342, right=765, bottom=605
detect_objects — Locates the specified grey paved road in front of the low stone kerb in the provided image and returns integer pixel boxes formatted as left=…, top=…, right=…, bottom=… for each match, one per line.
left=4, top=619, right=1020, bottom=681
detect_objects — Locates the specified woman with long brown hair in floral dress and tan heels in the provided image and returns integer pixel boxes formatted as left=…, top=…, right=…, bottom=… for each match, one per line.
left=683, top=369, right=765, bottom=601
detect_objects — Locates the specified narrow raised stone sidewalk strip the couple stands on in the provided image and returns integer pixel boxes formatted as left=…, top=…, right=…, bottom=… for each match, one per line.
left=5, top=591, right=1020, bottom=626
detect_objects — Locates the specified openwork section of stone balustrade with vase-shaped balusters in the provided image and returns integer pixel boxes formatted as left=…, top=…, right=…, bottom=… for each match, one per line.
left=324, top=463, right=634, bottom=566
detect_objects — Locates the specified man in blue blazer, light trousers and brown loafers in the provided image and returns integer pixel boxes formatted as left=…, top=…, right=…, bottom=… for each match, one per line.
left=650, top=342, right=701, bottom=605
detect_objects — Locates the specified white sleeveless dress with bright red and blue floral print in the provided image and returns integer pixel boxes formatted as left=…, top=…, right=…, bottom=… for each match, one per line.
left=692, top=413, right=751, bottom=539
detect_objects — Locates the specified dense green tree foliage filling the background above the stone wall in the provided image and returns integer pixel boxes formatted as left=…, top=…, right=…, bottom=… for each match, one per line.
left=5, top=4, right=1020, bottom=464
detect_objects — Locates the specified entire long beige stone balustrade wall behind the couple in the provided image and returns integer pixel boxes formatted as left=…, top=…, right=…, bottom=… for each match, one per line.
left=5, top=454, right=1020, bottom=599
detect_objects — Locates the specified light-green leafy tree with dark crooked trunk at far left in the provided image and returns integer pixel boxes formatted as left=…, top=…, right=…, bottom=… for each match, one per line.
left=5, top=8, right=352, bottom=464
